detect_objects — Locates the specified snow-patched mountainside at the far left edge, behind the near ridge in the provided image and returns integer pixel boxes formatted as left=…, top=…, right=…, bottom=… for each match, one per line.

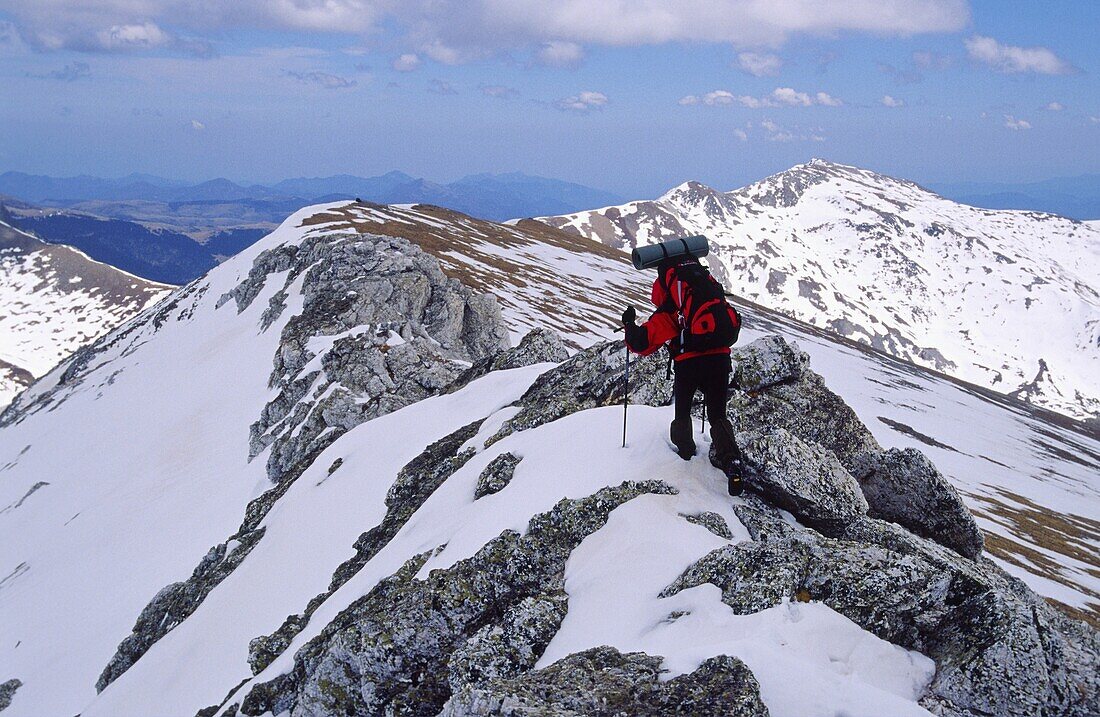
left=0, top=221, right=172, bottom=408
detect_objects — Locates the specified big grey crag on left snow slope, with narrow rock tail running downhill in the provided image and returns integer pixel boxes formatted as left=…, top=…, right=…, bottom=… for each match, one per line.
left=96, top=233, right=510, bottom=691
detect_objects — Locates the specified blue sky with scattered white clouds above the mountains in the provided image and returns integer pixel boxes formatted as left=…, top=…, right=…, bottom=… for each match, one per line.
left=0, top=0, right=1100, bottom=197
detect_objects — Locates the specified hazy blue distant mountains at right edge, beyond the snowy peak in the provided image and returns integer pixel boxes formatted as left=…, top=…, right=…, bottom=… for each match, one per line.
left=927, top=174, right=1100, bottom=220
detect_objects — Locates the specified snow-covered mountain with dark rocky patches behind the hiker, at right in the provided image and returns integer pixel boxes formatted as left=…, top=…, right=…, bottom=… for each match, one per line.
left=542, top=159, right=1100, bottom=419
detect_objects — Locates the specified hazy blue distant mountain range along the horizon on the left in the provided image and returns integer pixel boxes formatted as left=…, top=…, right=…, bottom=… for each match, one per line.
left=0, top=172, right=623, bottom=224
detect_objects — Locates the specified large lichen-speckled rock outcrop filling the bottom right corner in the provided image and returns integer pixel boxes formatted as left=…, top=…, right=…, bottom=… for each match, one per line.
left=664, top=488, right=1100, bottom=717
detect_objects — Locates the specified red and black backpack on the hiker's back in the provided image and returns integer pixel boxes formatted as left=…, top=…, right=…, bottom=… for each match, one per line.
left=660, top=260, right=741, bottom=355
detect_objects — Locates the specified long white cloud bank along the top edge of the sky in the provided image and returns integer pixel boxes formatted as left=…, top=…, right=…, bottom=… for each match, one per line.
left=3, top=0, right=969, bottom=58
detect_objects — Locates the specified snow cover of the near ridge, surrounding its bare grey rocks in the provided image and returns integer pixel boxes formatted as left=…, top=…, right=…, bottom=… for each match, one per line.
left=0, top=203, right=1100, bottom=717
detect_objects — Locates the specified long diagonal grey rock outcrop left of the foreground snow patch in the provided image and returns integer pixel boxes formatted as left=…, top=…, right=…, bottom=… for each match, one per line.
left=241, top=482, right=672, bottom=717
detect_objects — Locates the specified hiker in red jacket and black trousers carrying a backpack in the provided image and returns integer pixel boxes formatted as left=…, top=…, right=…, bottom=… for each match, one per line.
left=623, top=246, right=744, bottom=495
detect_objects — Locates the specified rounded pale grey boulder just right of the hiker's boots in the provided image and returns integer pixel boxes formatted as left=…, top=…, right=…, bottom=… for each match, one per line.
left=737, top=428, right=867, bottom=531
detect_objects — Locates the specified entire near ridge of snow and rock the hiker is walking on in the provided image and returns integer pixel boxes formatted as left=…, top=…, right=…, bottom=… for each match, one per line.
left=0, top=202, right=1100, bottom=717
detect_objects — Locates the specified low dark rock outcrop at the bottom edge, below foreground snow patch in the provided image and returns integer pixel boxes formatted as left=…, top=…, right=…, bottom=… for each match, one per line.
left=440, top=647, right=768, bottom=717
